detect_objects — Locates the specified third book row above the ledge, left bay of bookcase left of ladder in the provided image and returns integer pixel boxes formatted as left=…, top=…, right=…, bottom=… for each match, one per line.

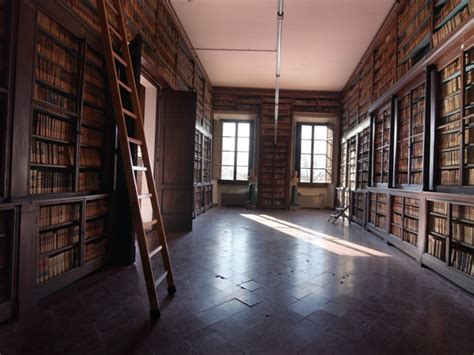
left=33, top=112, right=75, bottom=143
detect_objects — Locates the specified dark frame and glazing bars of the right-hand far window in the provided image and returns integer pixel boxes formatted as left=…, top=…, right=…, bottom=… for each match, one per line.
left=295, top=122, right=334, bottom=187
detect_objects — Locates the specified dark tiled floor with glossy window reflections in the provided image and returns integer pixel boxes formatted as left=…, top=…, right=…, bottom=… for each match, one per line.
left=0, top=209, right=474, bottom=355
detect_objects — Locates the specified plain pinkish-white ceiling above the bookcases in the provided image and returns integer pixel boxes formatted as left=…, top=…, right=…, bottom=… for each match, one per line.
left=170, top=0, right=394, bottom=91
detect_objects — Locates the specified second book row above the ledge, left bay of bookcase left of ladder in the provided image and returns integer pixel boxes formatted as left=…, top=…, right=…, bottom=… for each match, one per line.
left=31, top=140, right=74, bottom=166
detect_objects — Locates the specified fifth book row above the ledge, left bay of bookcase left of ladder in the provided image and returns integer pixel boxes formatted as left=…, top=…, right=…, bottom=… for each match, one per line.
left=35, top=56, right=76, bottom=95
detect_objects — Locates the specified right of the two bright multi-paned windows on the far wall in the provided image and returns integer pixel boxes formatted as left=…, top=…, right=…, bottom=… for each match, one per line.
left=295, top=123, right=333, bottom=184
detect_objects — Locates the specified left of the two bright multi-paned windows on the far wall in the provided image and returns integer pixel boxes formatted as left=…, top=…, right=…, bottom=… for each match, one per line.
left=221, top=121, right=252, bottom=181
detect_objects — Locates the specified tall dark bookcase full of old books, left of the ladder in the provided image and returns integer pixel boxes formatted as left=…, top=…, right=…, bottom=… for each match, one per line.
left=15, top=7, right=117, bottom=299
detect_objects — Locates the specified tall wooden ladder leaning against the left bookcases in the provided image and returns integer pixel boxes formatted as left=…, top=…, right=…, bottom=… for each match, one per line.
left=97, top=0, right=176, bottom=318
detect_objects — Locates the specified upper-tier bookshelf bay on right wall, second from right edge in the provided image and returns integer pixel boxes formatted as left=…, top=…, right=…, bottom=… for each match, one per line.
left=397, top=0, right=433, bottom=78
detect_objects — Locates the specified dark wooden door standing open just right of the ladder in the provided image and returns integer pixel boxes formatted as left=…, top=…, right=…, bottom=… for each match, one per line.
left=155, top=90, right=196, bottom=232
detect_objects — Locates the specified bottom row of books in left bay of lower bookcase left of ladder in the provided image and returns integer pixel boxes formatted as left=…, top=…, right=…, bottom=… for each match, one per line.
left=37, top=249, right=79, bottom=283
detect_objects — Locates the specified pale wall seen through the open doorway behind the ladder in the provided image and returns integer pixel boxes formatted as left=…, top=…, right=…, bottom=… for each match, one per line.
left=140, top=76, right=158, bottom=221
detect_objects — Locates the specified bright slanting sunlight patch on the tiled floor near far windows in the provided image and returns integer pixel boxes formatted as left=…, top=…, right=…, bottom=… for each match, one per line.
left=241, top=213, right=390, bottom=257
